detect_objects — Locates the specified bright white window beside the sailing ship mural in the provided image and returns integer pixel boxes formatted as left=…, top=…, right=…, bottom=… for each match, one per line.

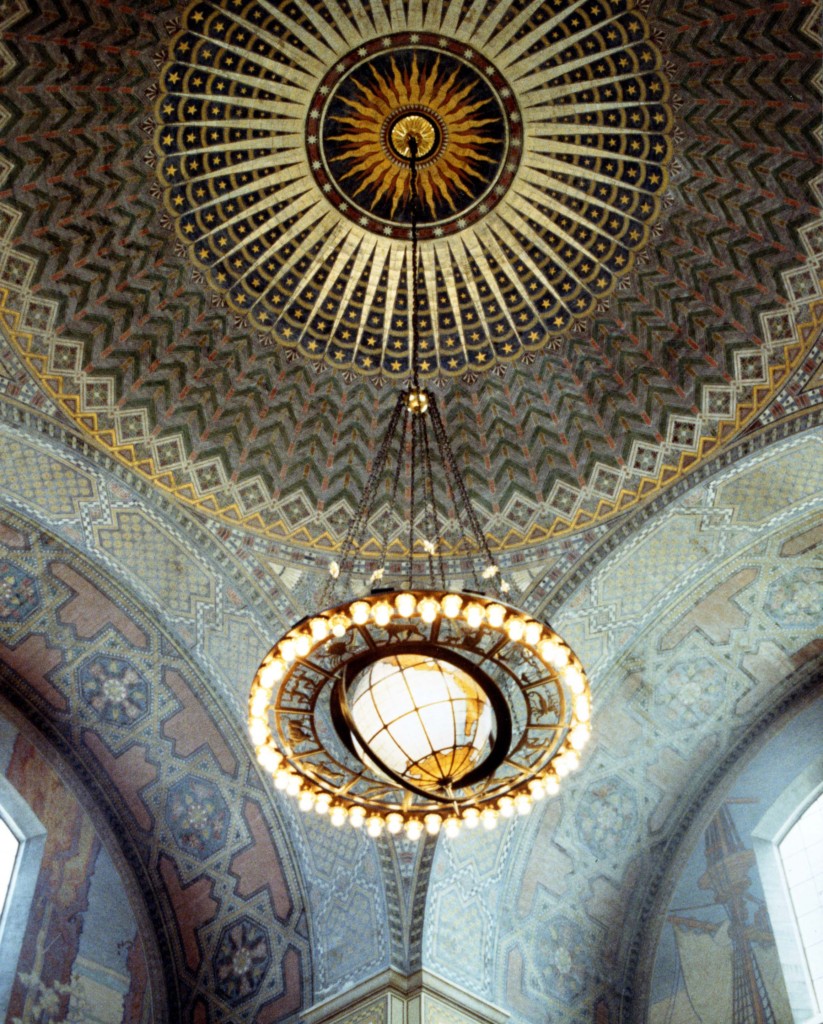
left=751, top=757, right=823, bottom=1024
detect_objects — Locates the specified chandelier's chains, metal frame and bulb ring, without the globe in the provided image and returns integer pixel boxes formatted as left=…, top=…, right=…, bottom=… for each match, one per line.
left=250, top=128, right=591, bottom=838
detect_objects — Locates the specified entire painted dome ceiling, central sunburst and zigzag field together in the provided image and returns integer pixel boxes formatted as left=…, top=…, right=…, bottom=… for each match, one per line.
left=2, top=0, right=821, bottom=556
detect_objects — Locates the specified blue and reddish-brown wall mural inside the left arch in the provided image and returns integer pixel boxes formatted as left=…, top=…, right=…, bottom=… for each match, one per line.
left=0, top=696, right=170, bottom=1024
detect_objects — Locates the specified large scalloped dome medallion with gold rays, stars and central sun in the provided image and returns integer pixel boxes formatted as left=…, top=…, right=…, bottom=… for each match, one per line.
left=156, top=0, right=673, bottom=379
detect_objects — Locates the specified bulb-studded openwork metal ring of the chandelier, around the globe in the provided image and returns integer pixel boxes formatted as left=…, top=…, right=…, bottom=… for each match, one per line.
left=249, top=590, right=591, bottom=839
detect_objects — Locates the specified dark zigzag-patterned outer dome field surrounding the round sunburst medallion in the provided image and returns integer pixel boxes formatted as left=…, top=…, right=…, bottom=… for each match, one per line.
left=0, top=0, right=823, bottom=552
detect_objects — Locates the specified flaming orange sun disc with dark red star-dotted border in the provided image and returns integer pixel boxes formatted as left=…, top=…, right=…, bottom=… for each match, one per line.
left=307, top=41, right=522, bottom=234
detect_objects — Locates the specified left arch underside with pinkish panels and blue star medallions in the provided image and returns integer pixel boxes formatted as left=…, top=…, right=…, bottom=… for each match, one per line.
left=0, top=503, right=312, bottom=1024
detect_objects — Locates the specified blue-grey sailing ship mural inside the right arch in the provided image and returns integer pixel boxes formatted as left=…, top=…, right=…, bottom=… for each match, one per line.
left=631, top=663, right=823, bottom=1024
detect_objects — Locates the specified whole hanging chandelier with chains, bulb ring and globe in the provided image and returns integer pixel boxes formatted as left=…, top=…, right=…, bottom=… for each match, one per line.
left=249, top=125, right=591, bottom=839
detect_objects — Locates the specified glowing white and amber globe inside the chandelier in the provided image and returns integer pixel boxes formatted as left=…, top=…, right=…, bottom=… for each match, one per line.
left=348, top=654, right=494, bottom=792
